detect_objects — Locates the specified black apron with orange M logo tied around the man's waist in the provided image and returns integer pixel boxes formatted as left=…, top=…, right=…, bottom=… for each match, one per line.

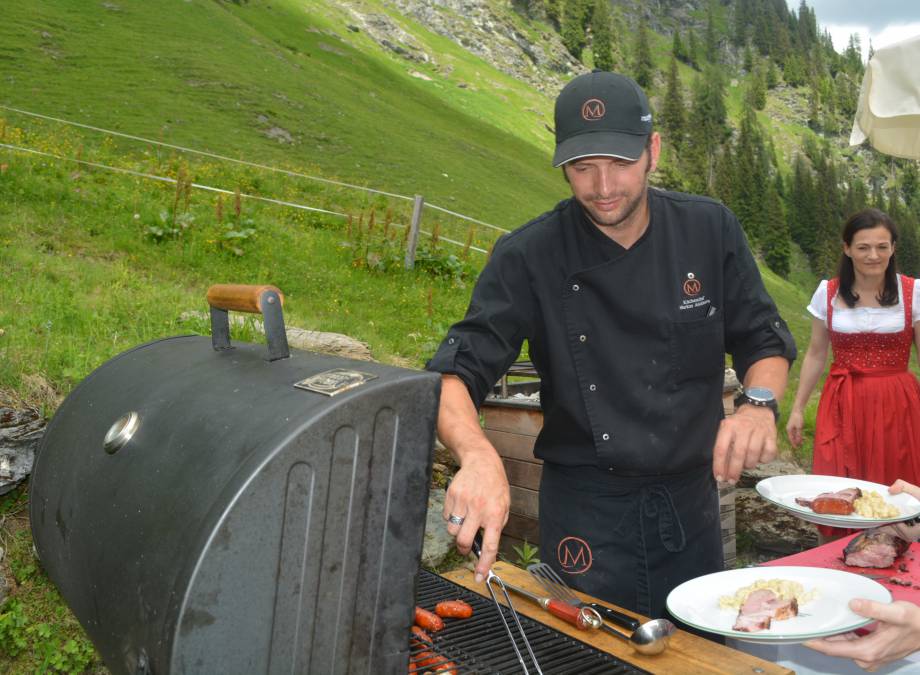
left=540, top=463, right=722, bottom=618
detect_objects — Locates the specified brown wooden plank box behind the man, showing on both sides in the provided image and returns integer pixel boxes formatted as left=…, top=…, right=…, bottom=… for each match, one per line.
left=481, top=373, right=737, bottom=569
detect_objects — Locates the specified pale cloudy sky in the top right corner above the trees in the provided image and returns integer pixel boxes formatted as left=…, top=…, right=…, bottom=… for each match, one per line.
left=786, top=0, right=920, bottom=59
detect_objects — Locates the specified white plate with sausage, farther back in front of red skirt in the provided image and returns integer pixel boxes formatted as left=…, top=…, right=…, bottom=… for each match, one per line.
left=756, top=475, right=920, bottom=529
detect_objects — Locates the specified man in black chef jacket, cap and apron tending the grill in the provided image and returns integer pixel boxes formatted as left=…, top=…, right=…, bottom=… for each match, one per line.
left=428, top=71, right=795, bottom=617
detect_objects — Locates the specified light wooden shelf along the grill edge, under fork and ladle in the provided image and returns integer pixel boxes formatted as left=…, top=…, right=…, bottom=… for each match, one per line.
left=441, top=562, right=793, bottom=675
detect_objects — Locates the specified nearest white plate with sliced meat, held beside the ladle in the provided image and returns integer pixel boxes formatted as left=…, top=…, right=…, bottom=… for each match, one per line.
left=667, top=566, right=891, bottom=644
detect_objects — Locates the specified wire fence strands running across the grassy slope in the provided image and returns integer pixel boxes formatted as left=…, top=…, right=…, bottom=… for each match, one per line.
left=0, top=103, right=510, bottom=263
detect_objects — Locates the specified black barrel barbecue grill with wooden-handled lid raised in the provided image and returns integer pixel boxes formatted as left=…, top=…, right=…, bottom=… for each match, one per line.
left=30, top=286, right=656, bottom=675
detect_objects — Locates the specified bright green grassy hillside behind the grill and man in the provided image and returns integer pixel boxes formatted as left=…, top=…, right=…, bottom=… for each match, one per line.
left=0, top=0, right=840, bottom=673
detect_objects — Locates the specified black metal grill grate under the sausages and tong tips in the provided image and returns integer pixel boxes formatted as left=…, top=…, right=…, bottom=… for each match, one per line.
left=409, top=570, right=648, bottom=675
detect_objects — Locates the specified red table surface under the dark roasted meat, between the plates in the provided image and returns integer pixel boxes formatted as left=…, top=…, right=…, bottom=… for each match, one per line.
left=763, top=534, right=920, bottom=605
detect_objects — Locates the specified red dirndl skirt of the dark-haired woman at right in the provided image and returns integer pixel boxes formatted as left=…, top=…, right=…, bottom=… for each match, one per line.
left=812, top=365, right=920, bottom=537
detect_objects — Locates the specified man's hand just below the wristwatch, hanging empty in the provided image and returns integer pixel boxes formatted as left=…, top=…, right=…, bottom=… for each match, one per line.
left=712, top=404, right=776, bottom=483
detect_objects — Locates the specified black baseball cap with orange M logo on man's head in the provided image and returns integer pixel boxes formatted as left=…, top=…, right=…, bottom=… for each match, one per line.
left=553, top=70, right=652, bottom=167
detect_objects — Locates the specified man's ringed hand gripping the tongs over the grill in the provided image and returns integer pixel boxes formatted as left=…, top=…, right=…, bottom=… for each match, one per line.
left=444, top=445, right=511, bottom=581
